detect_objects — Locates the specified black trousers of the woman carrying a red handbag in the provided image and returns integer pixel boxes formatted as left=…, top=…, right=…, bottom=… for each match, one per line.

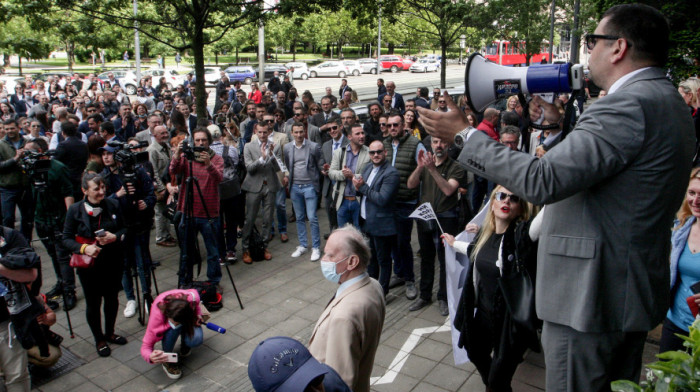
left=78, top=270, right=121, bottom=343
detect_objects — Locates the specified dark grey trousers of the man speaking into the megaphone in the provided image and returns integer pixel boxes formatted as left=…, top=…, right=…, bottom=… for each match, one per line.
left=542, top=321, right=647, bottom=392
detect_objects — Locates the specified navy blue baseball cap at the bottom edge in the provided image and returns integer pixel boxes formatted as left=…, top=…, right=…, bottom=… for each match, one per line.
left=248, top=336, right=328, bottom=392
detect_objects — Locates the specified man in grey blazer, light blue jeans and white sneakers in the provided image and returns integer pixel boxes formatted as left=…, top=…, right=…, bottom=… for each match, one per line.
left=283, top=122, right=325, bottom=261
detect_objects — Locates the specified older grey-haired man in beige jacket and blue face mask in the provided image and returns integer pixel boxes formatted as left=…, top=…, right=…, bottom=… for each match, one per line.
left=309, top=225, right=386, bottom=392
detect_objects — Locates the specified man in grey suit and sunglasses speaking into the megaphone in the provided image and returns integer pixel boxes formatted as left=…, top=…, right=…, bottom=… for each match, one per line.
left=419, top=4, right=695, bottom=391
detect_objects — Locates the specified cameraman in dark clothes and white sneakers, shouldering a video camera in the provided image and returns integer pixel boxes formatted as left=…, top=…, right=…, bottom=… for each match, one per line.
left=101, top=142, right=156, bottom=318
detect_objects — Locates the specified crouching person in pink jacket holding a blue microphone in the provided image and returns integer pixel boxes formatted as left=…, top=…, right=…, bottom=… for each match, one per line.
left=141, top=289, right=203, bottom=379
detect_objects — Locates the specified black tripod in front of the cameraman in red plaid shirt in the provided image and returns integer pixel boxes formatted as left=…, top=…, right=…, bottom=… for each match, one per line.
left=180, top=152, right=243, bottom=309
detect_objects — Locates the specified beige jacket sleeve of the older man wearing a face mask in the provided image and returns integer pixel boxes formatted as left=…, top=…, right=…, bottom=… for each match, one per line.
left=326, top=315, right=362, bottom=386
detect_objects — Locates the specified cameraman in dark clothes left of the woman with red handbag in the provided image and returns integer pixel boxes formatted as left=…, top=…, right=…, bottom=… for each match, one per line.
left=23, top=139, right=77, bottom=310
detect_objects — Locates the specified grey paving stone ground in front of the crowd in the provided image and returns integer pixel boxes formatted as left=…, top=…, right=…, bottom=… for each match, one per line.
left=28, top=203, right=658, bottom=392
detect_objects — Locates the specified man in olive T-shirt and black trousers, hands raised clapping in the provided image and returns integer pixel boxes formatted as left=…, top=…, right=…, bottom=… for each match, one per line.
left=408, top=136, right=464, bottom=316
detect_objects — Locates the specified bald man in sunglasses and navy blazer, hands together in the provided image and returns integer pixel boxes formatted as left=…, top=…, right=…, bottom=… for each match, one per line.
left=352, top=140, right=399, bottom=296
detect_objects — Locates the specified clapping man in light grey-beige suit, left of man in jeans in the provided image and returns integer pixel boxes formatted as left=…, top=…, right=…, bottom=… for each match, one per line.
left=241, top=122, right=282, bottom=264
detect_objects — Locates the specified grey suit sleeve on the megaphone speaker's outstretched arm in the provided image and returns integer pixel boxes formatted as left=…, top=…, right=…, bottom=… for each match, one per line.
left=459, top=93, right=645, bottom=204
